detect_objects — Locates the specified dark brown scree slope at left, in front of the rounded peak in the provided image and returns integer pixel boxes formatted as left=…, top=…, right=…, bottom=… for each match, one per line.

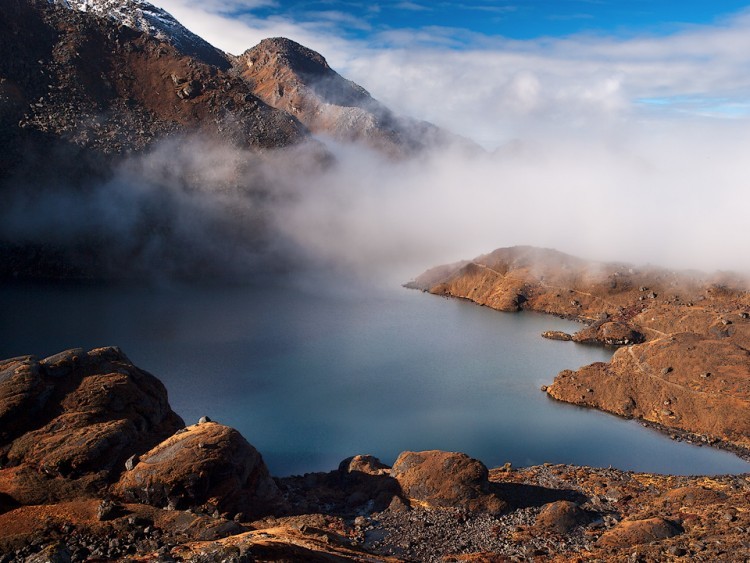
left=0, top=0, right=307, bottom=168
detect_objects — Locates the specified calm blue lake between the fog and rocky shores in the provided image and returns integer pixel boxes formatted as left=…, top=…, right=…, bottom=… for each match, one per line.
left=0, top=284, right=750, bottom=476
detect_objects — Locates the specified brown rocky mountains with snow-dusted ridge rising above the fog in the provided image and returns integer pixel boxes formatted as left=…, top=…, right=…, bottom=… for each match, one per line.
left=0, top=0, right=458, bottom=178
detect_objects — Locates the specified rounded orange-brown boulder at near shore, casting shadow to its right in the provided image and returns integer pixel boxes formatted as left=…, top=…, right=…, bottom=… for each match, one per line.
left=391, top=450, right=508, bottom=514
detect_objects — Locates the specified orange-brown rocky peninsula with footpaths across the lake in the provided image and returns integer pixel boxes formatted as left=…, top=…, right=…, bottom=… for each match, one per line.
left=409, top=247, right=750, bottom=453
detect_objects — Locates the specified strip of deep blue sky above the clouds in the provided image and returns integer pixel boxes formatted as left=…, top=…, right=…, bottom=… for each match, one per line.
left=225, top=0, right=747, bottom=44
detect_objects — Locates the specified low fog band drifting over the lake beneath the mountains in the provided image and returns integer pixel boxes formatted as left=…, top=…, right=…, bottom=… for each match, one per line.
left=0, top=122, right=750, bottom=281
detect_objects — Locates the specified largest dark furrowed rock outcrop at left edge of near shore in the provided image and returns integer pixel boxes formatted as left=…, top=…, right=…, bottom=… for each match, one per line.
left=0, top=348, right=183, bottom=504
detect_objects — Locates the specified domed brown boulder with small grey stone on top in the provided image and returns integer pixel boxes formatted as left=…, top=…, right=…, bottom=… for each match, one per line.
left=114, top=422, right=283, bottom=518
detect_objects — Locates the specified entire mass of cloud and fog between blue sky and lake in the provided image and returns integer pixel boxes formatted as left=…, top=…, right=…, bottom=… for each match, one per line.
left=5, top=0, right=750, bottom=281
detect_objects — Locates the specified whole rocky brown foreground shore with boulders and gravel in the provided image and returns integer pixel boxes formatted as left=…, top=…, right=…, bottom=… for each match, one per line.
left=0, top=348, right=750, bottom=563
